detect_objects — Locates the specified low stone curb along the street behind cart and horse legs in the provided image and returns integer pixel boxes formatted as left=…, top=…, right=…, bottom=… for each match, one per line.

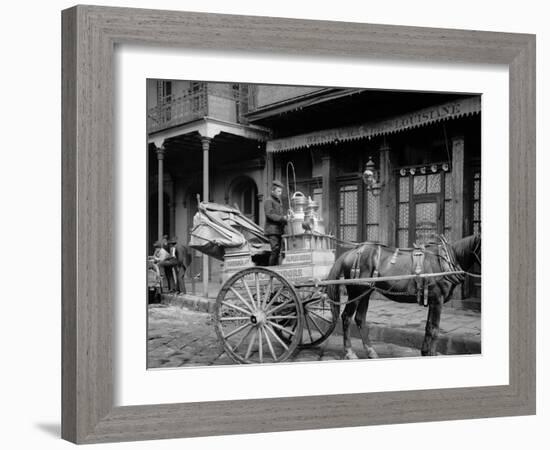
left=161, top=294, right=481, bottom=355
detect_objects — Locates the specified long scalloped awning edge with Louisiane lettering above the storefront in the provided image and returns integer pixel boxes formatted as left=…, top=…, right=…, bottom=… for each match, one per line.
left=266, top=96, right=481, bottom=153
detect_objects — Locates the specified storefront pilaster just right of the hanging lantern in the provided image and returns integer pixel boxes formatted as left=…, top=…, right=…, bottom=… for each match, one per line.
left=378, top=142, right=396, bottom=245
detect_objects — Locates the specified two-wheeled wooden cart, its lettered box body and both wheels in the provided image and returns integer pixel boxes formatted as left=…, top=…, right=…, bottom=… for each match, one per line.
left=214, top=233, right=339, bottom=363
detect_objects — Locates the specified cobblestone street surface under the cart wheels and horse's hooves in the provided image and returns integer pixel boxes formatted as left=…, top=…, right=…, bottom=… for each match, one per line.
left=147, top=304, right=420, bottom=368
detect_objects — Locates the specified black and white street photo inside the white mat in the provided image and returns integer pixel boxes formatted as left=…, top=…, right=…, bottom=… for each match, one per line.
left=147, top=79, right=482, bottom=369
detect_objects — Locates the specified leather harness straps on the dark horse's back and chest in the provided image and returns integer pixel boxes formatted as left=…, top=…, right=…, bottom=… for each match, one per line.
left=350, top=235, right=465, bottom=306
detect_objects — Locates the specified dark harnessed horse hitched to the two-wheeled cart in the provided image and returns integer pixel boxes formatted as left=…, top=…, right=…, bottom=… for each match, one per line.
left=327, top=235, right=481, bottom=359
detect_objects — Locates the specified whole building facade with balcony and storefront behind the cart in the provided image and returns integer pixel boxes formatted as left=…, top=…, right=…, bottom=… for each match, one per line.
left=148, top=80, right=481, bottom=307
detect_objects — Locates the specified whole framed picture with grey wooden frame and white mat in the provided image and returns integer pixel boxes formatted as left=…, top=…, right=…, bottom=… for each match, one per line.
left=62, top=6, right=535, bottom=443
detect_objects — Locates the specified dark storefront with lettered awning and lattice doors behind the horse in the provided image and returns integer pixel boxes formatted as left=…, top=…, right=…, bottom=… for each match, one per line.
left=260, top=96, right=481, bottom=298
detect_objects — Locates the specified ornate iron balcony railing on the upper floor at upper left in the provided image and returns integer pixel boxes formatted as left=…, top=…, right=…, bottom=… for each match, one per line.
left=147, top=83, right=251, bottom=133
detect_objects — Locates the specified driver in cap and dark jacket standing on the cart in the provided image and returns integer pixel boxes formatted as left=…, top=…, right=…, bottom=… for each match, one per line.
left=264, top=180, right=287, bottom=266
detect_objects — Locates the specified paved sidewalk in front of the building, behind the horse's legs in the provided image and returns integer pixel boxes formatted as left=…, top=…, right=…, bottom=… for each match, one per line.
left=162, top=288, right=481, bottom=355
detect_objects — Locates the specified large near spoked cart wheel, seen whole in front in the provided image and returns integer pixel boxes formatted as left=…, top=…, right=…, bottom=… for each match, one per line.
left=214, top=267, right=304, bottom=364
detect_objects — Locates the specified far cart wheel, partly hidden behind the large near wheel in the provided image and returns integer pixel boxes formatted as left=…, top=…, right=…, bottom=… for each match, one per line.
left=298, top=288, right=340, bottom=348
